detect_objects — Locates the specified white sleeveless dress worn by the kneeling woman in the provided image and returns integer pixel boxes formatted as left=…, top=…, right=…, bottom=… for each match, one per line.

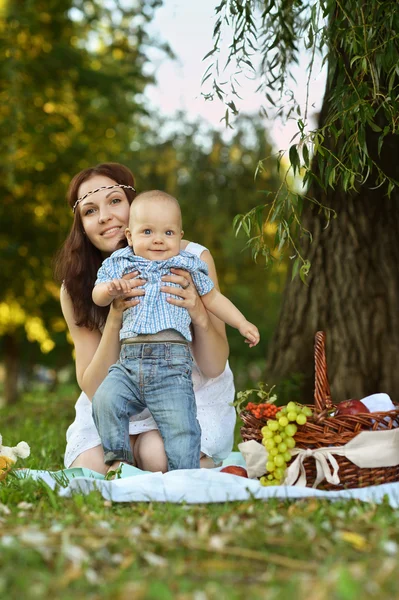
left=64, top=242, right=236, bottom=468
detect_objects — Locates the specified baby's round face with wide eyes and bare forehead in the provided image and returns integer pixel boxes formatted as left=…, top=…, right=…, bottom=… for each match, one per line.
left=126, top=199, right=183, bottom=260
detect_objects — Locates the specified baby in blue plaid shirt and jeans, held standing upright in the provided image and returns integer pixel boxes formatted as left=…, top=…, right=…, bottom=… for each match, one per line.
left=93, top=190, right=259, bottom=470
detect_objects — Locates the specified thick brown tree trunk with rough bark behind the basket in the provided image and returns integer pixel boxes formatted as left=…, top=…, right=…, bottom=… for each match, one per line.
left=267, top=100, right=399, bottom=403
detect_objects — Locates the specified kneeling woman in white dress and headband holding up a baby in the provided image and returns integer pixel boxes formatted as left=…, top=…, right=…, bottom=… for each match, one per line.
left=56, top=163, right=235, bottom=473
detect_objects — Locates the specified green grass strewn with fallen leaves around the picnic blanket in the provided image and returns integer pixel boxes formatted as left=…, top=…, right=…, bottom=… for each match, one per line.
left=0, top=387, right=399, bottom=600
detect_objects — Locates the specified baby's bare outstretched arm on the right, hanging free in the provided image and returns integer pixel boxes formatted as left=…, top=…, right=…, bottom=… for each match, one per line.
left=201, top=288, right=260, bottom=348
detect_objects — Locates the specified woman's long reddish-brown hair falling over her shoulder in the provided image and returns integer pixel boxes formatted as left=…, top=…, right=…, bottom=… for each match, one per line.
left=54, top=163, right=136, bottom=330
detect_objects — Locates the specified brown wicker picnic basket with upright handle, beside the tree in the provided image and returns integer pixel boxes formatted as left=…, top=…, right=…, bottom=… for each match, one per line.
left=240, top=331, right=399, bottom=490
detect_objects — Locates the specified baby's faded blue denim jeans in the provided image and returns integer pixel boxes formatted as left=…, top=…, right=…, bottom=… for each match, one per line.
left=93, top=343, right=201, bottom=471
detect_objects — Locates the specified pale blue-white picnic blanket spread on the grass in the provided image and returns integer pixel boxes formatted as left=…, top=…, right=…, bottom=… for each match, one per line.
left=15, top=452, right=399, bottom=508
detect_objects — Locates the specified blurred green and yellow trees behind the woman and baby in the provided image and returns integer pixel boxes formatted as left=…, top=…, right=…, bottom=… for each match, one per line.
left=0, top=0, right=287, bottom=404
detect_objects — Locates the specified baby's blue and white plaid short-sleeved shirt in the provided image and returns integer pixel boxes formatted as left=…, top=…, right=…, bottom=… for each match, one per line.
left=95, top=246, right=214, bottom=342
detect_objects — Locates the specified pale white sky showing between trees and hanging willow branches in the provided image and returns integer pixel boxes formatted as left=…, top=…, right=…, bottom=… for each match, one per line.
left=146, top=0, right=325, bottom=150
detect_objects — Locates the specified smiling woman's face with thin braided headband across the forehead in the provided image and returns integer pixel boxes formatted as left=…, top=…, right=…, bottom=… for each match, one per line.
left=77, top=175, right=130, bottom=255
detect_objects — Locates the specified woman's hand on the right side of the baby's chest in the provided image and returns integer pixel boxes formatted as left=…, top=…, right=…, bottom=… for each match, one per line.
left=161, top=269, right=209, bottom=326
